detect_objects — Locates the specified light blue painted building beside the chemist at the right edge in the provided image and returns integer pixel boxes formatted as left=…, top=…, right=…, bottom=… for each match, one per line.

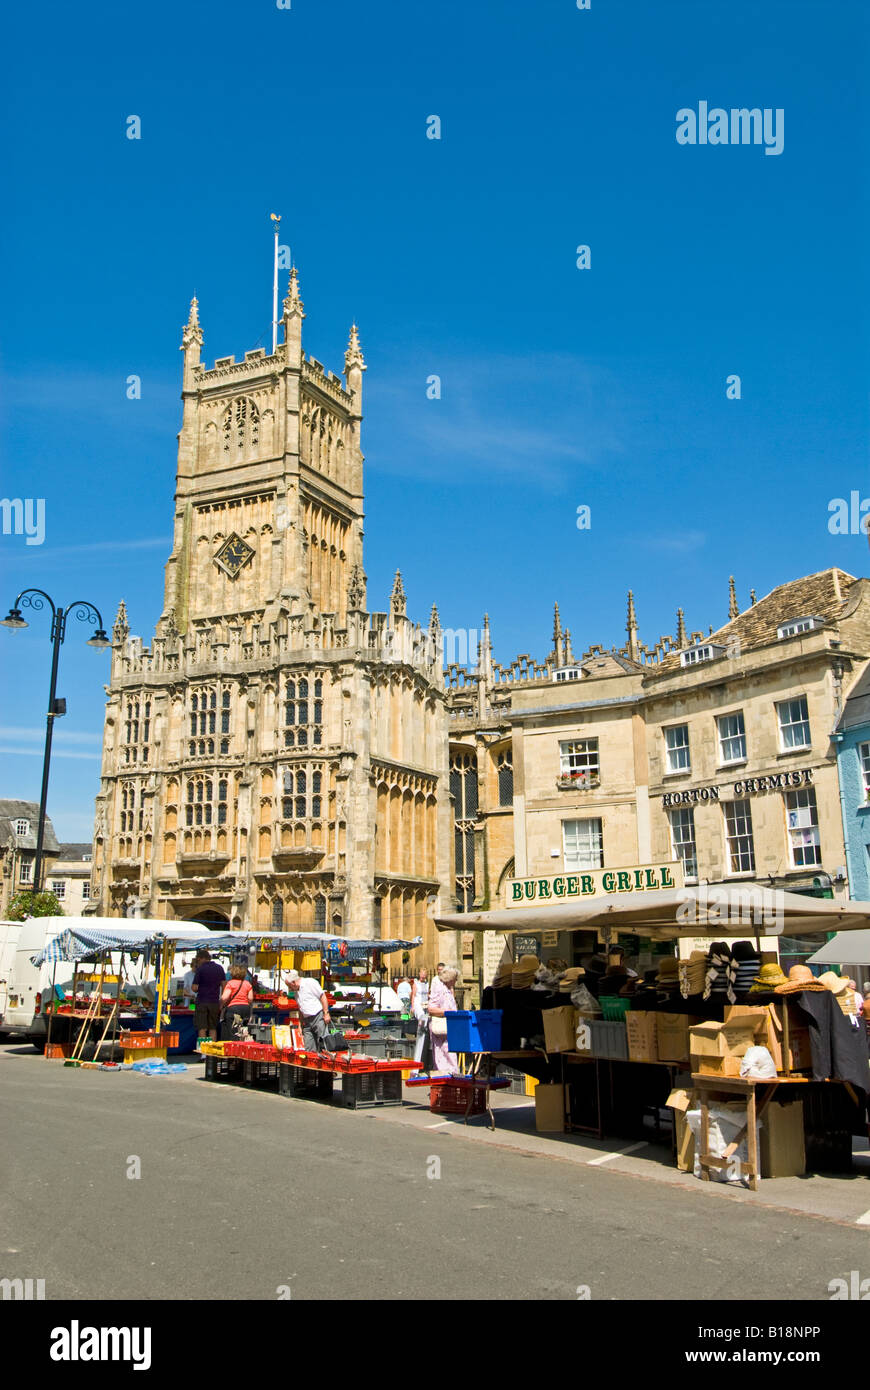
left=834, top=666, right=870, bottom=902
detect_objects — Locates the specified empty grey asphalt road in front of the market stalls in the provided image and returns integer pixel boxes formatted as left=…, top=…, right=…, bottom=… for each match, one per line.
left=0, top=1045, right=870, bottom=1301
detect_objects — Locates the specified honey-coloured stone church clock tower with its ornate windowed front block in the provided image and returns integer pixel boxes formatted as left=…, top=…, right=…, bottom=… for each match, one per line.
left=93, top=270, right=452, bottom=956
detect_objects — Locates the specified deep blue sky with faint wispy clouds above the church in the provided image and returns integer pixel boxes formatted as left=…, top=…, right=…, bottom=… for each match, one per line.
left=0, top=0, right=870, bottom=840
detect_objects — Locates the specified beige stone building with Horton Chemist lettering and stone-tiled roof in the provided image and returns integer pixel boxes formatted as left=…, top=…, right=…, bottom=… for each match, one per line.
left=643, top=569, right=870, bottom=897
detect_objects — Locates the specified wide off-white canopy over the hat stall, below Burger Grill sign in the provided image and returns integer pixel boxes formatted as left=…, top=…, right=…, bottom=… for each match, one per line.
left=435, top=883, right=870, bottom=945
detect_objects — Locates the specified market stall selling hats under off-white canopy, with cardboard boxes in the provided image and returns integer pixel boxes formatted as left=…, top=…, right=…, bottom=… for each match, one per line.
left=436, top=874, right=870, bottom=1186
